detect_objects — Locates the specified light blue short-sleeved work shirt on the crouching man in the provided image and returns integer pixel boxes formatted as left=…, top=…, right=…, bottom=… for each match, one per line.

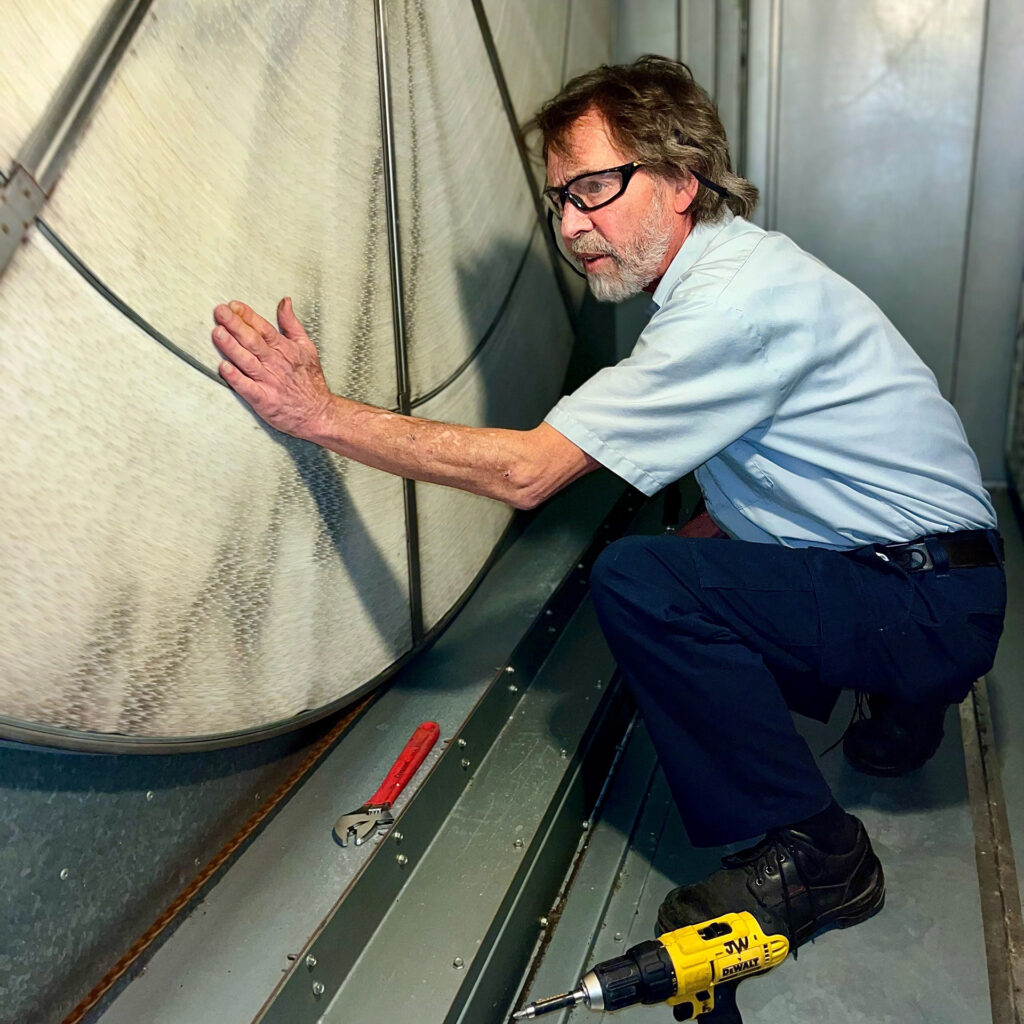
left=546, top=214, right=995, bottom=549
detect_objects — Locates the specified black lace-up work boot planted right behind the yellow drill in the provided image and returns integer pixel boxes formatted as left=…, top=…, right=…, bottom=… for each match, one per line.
left=657, top=818, right=886, bottom=948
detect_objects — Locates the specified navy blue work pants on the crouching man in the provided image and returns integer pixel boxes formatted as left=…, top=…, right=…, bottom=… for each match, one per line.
left=591, top=531, right=1006, bottom=846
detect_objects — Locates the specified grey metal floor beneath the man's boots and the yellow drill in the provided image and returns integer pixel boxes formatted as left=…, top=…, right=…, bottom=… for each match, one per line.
left=518, top=494, right=1024, bottom=1024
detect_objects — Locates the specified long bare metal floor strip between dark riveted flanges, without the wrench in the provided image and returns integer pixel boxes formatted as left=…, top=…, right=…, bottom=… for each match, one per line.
left=313, top=601, right=625, bottom=1024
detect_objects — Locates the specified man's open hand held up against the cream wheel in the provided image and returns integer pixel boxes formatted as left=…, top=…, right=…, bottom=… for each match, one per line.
left=213, top=298, right=333, bottom=437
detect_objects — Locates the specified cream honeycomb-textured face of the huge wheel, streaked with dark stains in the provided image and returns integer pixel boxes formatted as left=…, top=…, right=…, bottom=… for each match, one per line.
left=0, top=0, right=606, bottom=750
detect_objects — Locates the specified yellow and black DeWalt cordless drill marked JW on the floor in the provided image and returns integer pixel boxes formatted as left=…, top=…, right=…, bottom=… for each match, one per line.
left=512, top=910, right=790, bottom=1024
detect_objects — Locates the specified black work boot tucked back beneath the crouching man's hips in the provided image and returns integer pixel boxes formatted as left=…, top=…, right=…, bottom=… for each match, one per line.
left=843, top=693, right=948, bottom=776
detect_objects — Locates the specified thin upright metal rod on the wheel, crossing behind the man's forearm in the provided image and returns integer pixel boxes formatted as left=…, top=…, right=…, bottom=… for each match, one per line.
left=374, top=0, right=424, bottom=646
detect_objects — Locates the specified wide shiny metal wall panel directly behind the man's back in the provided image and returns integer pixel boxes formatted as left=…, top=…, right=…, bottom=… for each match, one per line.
left=768, top=0, right=985, bottom=395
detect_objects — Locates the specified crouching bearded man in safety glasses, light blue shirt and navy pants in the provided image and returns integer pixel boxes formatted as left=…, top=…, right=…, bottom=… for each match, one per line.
left=213, top=57, right=1005, bottom=946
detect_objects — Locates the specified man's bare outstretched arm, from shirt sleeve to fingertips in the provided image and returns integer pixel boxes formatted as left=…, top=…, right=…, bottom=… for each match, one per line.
left=213, top=299, right=599, bottom=509
